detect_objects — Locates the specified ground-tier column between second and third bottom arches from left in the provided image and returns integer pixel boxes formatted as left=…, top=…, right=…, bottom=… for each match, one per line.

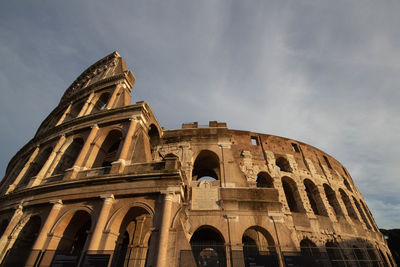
left=88, top=194, right=114, bottom=251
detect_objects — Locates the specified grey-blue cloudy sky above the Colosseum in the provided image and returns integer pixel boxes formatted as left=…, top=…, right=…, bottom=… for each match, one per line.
left=0, top=0, right=400, bottom=228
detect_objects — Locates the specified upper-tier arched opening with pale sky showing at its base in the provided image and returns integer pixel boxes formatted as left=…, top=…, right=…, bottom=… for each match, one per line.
left=192, top=150, right=220, bottom=181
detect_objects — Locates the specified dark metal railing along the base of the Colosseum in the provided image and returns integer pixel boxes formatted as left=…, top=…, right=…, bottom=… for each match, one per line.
left=0, top=247, right=391, bottom=267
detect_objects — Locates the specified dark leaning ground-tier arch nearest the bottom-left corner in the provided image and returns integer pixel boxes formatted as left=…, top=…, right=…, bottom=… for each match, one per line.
left=1, top=216, right=41, bottom=267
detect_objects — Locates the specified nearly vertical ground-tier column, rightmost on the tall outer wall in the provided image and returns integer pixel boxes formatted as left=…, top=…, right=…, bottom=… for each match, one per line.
left=156, top=193, right=173, bottom=267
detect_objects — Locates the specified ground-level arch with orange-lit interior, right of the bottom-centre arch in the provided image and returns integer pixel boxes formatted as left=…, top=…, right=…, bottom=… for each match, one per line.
left=242, top=226, right=278, bottom=267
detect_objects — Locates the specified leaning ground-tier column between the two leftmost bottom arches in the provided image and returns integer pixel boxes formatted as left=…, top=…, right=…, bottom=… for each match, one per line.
left=26, top=200, right=63, bottom=266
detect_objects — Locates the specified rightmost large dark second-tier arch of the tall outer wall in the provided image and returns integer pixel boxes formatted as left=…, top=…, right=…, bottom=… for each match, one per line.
left=92, top=130, right=122, bottom=171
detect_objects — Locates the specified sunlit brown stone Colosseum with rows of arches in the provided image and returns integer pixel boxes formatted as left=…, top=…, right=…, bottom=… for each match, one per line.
left=0, top=52, right=396, bottom=267
